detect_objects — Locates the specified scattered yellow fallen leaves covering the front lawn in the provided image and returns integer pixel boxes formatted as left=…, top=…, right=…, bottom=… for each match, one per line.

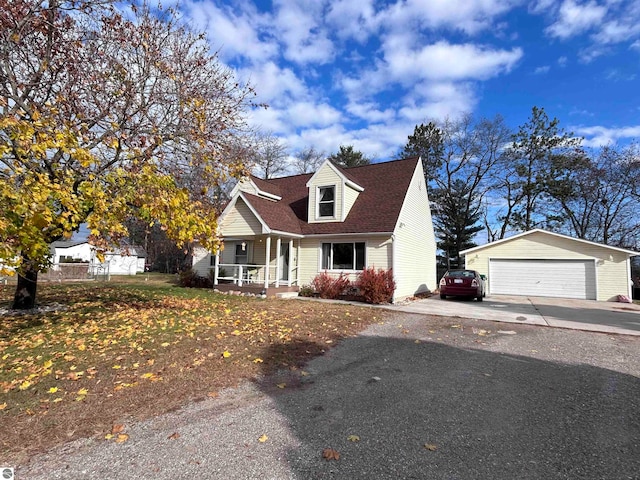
left=0, top=284, right=370, bottom=412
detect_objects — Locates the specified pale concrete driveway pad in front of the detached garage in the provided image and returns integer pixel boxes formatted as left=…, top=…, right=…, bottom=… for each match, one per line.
left=392, top=295, right=640, bottom=335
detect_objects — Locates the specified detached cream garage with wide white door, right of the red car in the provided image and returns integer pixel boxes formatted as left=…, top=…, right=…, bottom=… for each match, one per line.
left=460, top=229, right=640, bottom=301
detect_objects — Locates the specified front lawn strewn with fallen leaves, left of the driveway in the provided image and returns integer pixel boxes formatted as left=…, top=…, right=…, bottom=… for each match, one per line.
left=0, top=276, right=384, bottom=465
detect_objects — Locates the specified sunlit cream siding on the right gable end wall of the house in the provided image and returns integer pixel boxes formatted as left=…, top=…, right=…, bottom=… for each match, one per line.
left=393, top=162, right=437, bottom=301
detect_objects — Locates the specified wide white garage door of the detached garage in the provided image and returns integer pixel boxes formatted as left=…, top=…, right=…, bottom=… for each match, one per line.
left=489, top=259, right=596, bottom=300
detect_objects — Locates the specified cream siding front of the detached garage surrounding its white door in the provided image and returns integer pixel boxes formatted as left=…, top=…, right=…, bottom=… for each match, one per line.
left=465, top=232, right=629, bottom=301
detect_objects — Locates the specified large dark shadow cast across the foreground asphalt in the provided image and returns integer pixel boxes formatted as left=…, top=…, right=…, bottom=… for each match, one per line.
left=261, top=330, right=640, bottom=480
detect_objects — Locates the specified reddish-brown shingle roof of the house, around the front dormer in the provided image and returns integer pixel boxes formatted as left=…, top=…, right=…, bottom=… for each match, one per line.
left=235, top=157, right=419, bottom=235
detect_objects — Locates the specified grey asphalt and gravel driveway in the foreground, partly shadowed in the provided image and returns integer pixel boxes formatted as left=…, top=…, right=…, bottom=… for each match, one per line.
left=17, top=311, right=640, bottom=480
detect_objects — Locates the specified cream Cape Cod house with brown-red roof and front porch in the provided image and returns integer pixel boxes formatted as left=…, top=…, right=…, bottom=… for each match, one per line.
left=193, top=157, right=437, bottom=301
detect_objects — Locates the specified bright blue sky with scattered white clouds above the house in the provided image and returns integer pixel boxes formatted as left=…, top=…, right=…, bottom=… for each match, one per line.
left=170, top=0, right=640, bottom=161
